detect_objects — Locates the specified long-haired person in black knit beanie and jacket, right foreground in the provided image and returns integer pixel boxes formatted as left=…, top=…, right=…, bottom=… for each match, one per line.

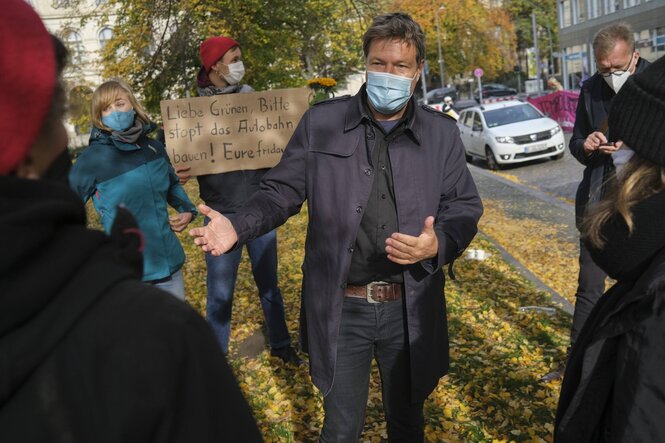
left=555, top=53, right=665, bottom=443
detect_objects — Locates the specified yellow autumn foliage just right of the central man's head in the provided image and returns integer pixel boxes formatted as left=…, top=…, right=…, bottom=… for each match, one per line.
left=392, top=0, right=515, bottom=79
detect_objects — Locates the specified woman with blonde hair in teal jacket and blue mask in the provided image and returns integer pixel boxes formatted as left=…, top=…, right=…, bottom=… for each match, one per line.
left=69, top=80, right=196, bottom=300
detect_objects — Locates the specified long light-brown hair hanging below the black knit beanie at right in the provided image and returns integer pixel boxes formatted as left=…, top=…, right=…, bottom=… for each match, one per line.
left=582, top=154, right=665, bottom=248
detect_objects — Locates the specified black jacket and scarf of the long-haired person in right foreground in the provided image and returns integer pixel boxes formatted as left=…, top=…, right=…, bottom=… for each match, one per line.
left=555, top=191, right=665, bottom=443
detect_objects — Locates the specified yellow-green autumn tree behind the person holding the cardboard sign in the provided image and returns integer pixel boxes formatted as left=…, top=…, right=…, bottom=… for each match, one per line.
left=88, top=0, right=382, bottom=116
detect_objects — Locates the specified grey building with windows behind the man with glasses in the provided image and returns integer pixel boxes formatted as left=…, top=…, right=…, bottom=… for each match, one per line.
left=558, top=0, right=665, bottom=89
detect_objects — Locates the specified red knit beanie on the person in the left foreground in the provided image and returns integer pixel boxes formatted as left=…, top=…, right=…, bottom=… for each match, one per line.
left=0, top=0, right=56, bottom=175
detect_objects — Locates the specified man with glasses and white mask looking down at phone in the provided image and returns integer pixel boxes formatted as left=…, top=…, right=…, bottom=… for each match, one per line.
left=541, top=23, right=649, bottom=381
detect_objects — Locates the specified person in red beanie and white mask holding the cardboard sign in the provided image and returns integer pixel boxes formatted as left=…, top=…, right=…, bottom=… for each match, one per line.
left=184, top=36, right=302, bottom=365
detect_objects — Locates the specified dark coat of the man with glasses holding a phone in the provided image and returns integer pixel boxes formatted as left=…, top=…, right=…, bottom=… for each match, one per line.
left=568, top=58, right=649, bottom=225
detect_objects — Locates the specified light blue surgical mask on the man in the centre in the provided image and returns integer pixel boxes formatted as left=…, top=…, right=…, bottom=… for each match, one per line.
left=367, top=71, right=416, bottom=115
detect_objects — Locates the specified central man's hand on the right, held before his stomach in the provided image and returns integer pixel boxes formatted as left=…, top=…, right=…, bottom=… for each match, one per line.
left=386, top=216, right=439, bottom=265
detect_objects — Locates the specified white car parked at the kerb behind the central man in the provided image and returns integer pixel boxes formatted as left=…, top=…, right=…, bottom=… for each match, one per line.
left=457, top=100, right=565, bottom=170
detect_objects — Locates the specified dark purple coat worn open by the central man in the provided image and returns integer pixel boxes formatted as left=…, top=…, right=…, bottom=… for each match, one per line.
left=231, top=88, right=482, bottom=400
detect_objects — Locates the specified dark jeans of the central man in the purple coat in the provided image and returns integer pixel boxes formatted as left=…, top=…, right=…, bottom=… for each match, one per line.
left=321, top=297, right=425, bottom=443
